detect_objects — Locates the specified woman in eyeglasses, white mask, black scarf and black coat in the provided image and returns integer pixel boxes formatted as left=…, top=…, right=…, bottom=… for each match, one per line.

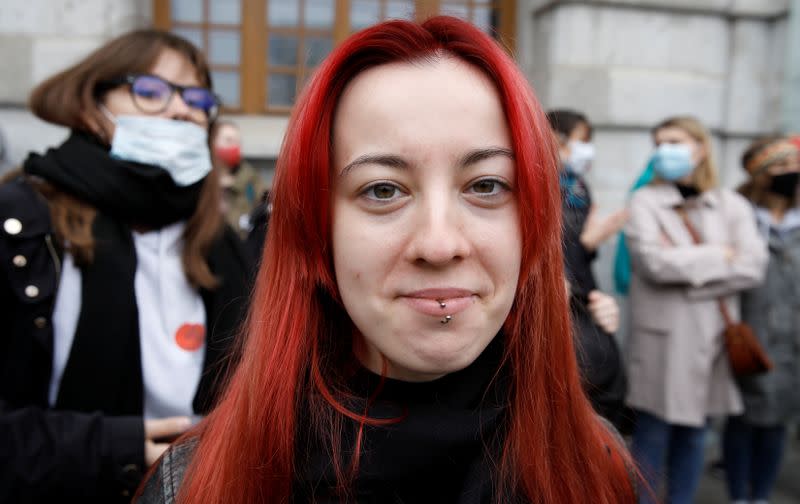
left=0, top=30, right=249, bottom=502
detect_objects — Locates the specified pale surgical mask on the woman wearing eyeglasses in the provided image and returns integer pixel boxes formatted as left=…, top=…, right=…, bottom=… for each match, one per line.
left=101, top=107, right=211, bottom=186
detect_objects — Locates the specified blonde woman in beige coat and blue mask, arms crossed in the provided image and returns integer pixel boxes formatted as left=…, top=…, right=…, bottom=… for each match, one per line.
left=625, top=117, right=767, bottom=504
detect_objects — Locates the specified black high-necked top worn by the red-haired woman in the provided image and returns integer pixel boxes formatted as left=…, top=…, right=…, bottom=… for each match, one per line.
left=293, top=336, right=507, bottom=504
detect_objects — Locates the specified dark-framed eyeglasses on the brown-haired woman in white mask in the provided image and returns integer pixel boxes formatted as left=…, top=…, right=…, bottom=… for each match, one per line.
left=107, top=74, right=220, bottom=122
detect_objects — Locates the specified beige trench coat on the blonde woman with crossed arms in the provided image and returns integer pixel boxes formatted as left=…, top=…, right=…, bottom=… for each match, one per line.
left=625, top=184, right=768, bottom=427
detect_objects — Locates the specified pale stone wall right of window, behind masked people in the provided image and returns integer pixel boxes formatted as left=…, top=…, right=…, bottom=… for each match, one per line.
left=517, top=0, right=800, bottom=298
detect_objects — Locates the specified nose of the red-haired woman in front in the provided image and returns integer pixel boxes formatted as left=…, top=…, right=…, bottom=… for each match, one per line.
left=408, top=197, right=470, bottom=266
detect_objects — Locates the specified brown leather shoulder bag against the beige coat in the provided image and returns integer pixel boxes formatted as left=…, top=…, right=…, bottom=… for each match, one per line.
left=678, top=208, right=772, bottom=376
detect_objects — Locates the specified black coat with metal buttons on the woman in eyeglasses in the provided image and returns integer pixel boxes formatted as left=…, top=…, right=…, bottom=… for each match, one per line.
left=0, top=178, right=250, bottom=502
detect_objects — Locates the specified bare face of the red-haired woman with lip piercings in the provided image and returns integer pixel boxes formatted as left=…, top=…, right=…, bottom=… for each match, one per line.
left=332, top=59, right=522, bottom=381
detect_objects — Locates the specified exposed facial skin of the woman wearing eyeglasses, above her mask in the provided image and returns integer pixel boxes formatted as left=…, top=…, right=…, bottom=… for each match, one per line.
left=102, top=49, right=208, bottom=137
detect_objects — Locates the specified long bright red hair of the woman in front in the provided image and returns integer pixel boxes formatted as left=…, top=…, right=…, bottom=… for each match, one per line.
left=175, top=17, right=635, bottom=504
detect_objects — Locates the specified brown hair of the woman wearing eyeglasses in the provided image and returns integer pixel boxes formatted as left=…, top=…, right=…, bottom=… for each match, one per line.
left=29, top=30, right=223, bottom=288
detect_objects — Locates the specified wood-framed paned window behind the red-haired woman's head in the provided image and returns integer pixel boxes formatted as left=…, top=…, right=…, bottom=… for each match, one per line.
left=154, top=0, right=516, bottom=114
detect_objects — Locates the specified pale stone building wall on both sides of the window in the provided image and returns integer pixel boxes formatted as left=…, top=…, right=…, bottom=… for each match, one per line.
left=0, top=0, right=800, bottom=210
